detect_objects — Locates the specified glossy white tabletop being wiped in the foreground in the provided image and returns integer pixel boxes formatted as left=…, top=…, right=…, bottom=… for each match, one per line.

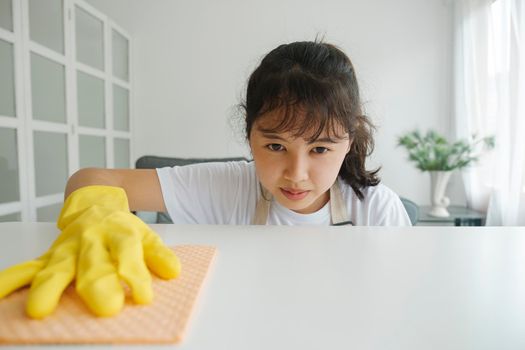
left=0, top=223, right=525, bottom=350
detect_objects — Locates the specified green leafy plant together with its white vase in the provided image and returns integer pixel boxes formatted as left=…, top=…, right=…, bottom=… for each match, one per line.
left=398, top=130, right=494, bottom=217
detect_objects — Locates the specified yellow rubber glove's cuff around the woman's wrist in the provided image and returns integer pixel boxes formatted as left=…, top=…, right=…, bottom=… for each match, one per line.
left=57, top=185, right=129, bottom=230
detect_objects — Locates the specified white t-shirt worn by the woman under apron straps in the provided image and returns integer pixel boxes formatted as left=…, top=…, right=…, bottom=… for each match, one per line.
left=157, top=161, right=410, bottom=226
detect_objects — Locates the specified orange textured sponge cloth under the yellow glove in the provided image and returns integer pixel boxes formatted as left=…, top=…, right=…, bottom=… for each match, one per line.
left=0, top=246, right=216, bottom=344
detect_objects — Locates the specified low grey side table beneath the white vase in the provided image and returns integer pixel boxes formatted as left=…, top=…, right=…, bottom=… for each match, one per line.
left=417, top=205, right=485, bottom=226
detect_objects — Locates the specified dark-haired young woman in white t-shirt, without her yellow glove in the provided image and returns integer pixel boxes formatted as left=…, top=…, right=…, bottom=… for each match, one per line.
left=66, top=42, right=410, bottom=225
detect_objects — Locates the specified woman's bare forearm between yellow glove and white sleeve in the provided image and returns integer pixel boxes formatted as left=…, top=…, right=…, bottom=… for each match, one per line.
left=64, top=168, right=166, bottom=211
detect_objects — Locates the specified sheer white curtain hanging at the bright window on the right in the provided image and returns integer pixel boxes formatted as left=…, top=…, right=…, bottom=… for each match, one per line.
left=454, top=0, right=525, bottom=225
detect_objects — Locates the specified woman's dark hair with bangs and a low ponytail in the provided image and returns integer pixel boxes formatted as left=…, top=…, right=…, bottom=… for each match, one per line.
left=241, top=41, right=380, bottom=199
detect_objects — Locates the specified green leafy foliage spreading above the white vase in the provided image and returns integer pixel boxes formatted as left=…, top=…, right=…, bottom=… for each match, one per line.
left=398, top=130, right=494, bottom=171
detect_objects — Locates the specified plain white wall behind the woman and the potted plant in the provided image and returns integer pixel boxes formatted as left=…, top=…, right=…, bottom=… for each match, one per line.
left=89, top=0, right=464, bottom=203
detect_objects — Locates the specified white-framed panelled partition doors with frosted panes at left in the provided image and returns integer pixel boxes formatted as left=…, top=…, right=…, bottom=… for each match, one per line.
left=0, top=0, right=131, bottom=221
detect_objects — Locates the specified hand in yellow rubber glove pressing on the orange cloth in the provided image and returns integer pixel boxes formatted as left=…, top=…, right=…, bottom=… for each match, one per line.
left=0, top=186, right=181, bottom=318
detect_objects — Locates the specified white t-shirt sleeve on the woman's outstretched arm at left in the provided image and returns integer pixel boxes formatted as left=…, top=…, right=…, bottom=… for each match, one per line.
left=157, top=162, right=255, bottom=224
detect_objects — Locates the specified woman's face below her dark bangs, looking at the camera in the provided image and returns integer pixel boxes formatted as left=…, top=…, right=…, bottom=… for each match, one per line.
left=250, top=112, right=351, bottom=214
